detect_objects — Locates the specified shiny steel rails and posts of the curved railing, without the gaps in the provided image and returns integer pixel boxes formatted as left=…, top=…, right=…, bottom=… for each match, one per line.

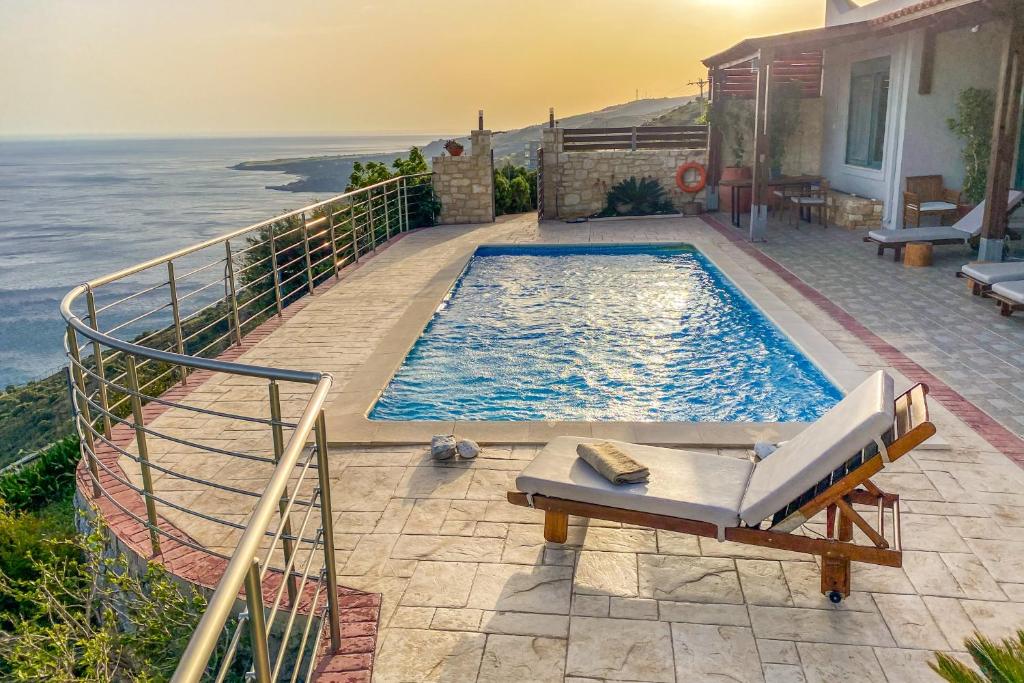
left=60, top=173, right=429, bottom=683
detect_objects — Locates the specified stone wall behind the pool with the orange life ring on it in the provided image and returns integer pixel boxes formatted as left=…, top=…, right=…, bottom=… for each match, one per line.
left=542, top=128, right=708, bottom=219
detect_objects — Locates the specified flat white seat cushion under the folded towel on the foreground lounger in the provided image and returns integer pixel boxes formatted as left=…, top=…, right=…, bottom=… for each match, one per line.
left=516, top=436, right=753, bottom=527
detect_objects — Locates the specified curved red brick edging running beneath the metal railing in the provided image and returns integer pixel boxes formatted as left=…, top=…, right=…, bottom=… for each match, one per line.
left=76, top=230, right=417, bottom=683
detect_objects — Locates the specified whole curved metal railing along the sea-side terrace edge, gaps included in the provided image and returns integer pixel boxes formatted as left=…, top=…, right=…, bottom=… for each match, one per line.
left=60, top=174, right=436, bottom=683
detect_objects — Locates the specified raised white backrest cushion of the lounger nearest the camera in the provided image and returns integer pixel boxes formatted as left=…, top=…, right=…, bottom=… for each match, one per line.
left=739, top=371, right=895, bottom=524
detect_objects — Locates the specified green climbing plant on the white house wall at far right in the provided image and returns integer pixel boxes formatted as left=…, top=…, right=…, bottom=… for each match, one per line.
left=946, top=88, right=995, bottom=204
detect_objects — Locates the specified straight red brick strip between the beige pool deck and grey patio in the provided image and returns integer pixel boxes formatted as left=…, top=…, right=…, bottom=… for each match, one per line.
left=701, top=215, right=1024, bottom=467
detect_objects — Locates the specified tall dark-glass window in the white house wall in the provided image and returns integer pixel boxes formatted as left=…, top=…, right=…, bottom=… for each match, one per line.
left=846, top=57, right=890, bottom=168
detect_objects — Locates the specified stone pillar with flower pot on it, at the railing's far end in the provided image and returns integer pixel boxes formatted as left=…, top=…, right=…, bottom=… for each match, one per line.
left=431, top=130, right=495, bottom=225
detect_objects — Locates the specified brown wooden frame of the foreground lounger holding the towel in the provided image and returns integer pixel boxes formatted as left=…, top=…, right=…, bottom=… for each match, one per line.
left=508, top=384, right=935, bottom=602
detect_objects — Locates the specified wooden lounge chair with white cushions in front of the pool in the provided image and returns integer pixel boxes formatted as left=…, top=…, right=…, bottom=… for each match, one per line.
left=508, top=372, right=935, bottom=602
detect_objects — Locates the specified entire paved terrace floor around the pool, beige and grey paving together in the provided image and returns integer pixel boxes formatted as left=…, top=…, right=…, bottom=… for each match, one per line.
left=116, top=211, right=1024, bottom=683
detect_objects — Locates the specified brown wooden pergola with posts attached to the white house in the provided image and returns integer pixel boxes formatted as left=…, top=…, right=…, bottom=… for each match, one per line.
left=703, top=0, right=1024, bottom=248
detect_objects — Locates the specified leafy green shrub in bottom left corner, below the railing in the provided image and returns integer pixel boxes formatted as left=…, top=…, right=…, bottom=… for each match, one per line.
left=0, top=518, right=241, bottom=683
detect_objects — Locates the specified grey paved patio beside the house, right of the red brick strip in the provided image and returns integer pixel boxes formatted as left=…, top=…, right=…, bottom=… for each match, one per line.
left=741, top=223, right=1024, bottom=435
